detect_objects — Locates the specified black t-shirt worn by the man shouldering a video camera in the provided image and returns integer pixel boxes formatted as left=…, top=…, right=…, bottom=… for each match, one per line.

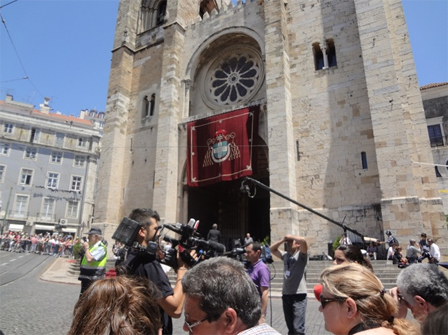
left=124, top=251, right=174, bottom=335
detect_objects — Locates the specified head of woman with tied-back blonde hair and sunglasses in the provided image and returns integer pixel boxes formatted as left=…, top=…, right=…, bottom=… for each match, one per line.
left=319, top=263, right=413, bottom=335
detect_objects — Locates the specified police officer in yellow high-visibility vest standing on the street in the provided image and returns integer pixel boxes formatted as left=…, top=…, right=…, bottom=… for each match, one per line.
left=78, top=228, right=107, bottom=294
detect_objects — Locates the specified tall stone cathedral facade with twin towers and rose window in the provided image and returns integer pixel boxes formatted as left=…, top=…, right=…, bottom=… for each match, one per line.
left=94, top=0, right=448, bottom=253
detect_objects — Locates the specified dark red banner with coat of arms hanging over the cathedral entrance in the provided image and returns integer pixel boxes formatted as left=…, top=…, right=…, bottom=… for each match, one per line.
left=187, top=106, right=259, bottom=186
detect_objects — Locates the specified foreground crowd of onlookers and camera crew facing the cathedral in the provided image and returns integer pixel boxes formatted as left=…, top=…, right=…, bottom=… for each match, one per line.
left=64, top=213, right=448, bottom=335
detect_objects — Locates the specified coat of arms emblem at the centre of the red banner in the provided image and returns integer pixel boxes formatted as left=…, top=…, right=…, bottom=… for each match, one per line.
left=202, top=129, right=240, bottom=166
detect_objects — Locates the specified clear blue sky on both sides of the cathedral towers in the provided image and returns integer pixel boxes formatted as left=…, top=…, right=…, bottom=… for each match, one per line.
left=0, top=0, right=448, bottom=115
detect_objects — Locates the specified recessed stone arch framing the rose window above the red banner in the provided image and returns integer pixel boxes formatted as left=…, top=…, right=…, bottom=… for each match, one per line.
left=183, top=27, right=265, bottom=116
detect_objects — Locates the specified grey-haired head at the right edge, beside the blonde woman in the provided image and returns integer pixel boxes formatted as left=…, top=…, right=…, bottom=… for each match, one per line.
left=397, top=263, right=448, bottom=322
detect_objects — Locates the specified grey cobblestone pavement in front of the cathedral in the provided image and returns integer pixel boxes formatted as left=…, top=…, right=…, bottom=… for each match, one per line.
left=0, top=252, right=330, bottom=335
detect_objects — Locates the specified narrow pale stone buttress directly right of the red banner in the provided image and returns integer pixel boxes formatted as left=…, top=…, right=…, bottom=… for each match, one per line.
left=263, top=0, right=300, bottom=241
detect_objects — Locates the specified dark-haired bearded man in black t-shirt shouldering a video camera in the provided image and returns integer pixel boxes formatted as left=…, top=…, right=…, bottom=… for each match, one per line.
left=119, top=208, right=187, bottom=334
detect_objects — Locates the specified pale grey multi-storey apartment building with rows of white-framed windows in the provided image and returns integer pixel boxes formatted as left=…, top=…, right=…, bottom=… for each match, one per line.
left=0, top=95, right=101, bottom=235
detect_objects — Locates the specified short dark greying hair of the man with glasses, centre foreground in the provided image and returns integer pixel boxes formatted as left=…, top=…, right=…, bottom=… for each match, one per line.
left=182, top=257, right=261, bottom=328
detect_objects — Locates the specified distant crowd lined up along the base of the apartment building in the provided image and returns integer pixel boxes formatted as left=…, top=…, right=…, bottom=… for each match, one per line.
left=0, top=231, right=78, bottom=257
